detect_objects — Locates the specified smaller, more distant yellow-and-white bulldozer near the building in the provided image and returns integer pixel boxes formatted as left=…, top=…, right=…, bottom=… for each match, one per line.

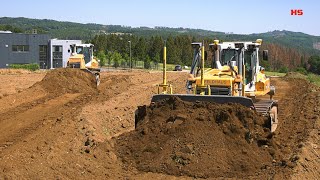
left=67, top=44, right=101, bottom=86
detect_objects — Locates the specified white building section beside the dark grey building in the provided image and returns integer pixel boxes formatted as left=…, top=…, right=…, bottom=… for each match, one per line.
left=49, top=39, right=82, bottom=68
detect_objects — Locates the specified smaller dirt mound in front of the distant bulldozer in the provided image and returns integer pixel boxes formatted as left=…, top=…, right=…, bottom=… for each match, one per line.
left=35, top=68, right=97, bottom=94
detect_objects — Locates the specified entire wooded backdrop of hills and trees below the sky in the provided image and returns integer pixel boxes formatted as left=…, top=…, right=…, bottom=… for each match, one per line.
left=0, top=17, right=320, bottom=70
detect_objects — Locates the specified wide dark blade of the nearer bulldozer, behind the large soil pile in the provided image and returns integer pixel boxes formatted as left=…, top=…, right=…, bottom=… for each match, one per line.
left=151, top=94, right=254, bottom=109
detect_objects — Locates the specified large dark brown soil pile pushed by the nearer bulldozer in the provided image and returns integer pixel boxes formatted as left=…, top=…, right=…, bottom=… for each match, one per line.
left=116, top=97, right=276, bottom=178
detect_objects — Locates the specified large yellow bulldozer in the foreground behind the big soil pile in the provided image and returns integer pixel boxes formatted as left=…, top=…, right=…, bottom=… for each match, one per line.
left=151, top=39, right=278, bottom=132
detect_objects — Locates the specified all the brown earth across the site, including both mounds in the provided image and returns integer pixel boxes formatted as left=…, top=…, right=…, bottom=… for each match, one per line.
left=0, top=69, right=320, bottom=179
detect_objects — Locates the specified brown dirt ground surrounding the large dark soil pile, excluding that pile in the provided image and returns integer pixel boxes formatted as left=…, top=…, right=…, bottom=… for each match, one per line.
left=0, top=71, right=320, bottom=179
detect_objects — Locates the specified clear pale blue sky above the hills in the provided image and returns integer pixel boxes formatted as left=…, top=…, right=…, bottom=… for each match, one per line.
left=0, top=0, right=320, bottom=36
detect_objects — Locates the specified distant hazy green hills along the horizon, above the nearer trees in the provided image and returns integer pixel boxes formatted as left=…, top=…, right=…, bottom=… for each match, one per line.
left=0, top=17, right=320, bottom=54
